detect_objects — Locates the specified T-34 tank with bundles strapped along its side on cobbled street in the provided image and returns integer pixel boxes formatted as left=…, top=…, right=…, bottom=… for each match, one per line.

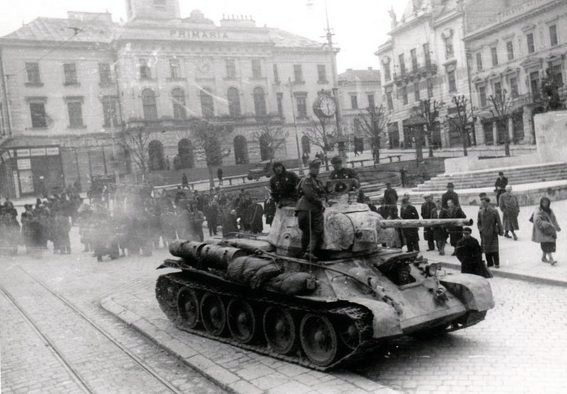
left=156, top=180, right=494, bottom=370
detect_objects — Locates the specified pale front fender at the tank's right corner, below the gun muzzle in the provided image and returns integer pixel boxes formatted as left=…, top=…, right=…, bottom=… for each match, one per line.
left=439, top=274, right=494, bottom=312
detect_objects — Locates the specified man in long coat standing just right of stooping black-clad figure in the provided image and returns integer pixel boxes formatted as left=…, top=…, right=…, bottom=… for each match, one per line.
left=477, top=197, right=503, bottom=268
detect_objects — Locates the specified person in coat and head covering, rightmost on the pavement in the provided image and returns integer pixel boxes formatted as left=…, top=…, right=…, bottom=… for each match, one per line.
left=530, top=197, right=561, bottom=265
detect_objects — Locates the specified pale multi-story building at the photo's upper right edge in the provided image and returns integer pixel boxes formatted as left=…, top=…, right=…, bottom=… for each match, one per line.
left=465, top=0, right=567, bottom=145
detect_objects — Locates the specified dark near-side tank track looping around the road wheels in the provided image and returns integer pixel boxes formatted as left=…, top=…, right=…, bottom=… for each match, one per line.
left=156, top=270, right=381, bottom=371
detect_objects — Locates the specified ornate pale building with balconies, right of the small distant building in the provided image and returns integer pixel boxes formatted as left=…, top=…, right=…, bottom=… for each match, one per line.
left=376, top=0, right=469, bottom=148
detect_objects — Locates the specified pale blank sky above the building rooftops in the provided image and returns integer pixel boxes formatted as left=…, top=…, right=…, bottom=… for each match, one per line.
left=0, top=0, right=408, bottom=71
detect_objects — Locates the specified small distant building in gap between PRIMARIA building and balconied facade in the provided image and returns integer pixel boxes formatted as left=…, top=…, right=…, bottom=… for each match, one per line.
left=338, top=67, right=382, bottom=152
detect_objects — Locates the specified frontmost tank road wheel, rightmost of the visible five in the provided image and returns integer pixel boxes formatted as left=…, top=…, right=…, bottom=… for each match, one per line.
left=299, top=314, right=338, bottom=367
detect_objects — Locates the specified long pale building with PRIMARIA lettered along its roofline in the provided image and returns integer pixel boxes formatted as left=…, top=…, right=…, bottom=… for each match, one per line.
left=0, top=0, right=337, bottom=196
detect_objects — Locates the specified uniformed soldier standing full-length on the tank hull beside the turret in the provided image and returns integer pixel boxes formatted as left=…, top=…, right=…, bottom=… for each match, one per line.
left=296, top=159, right=326, bottom=260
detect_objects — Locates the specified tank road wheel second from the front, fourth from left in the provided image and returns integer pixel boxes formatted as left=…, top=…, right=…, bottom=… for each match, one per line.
left=263, top=306, right=296, bottom=355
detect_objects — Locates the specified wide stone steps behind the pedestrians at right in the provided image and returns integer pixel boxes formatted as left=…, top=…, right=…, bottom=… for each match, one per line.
left=413, top=162, right=567, bottom=192
